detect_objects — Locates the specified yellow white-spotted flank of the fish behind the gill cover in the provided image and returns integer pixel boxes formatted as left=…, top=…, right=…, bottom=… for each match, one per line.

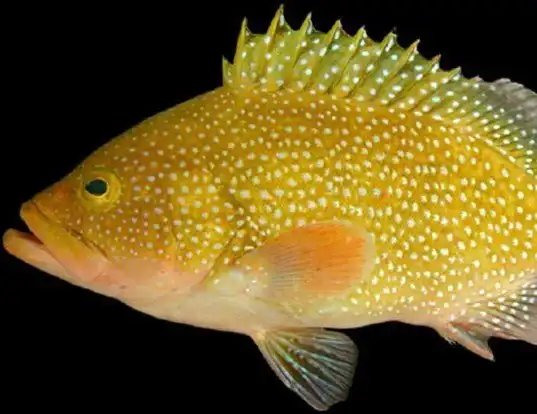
left=188, top=88, right=537, bottom=326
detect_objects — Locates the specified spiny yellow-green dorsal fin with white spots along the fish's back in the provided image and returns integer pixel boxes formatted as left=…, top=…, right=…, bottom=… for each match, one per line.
left=223, top=6, right=537, bottom=175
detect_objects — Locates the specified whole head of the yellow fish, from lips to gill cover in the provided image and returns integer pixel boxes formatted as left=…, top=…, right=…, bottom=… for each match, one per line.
left=3, top=131, right=226, bottom=299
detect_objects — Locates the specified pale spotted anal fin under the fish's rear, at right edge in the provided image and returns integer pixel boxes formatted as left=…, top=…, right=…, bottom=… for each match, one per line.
left=439, top=270, right=537, bottom=360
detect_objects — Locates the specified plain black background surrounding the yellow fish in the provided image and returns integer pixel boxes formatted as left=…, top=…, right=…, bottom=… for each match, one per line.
left=0, top=0, right=537, bottom=413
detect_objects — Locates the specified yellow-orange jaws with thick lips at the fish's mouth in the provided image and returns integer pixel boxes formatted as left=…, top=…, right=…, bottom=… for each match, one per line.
left=3, top=200, right=107, bottom=284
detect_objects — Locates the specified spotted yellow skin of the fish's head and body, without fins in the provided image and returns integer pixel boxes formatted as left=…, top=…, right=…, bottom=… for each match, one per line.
left=7, top=86, right=537, bottom=328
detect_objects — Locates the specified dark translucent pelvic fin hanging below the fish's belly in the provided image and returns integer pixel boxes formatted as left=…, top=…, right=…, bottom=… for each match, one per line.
left=253, top=328, right=358, bottom=411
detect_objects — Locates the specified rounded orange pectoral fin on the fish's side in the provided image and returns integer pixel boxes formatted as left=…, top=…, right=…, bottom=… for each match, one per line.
left=240, top=221, right=375, bottom=297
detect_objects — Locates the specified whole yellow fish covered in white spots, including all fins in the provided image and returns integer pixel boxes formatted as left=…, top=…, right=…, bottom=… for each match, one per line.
left=3, top=6, right=537, bottom=411
